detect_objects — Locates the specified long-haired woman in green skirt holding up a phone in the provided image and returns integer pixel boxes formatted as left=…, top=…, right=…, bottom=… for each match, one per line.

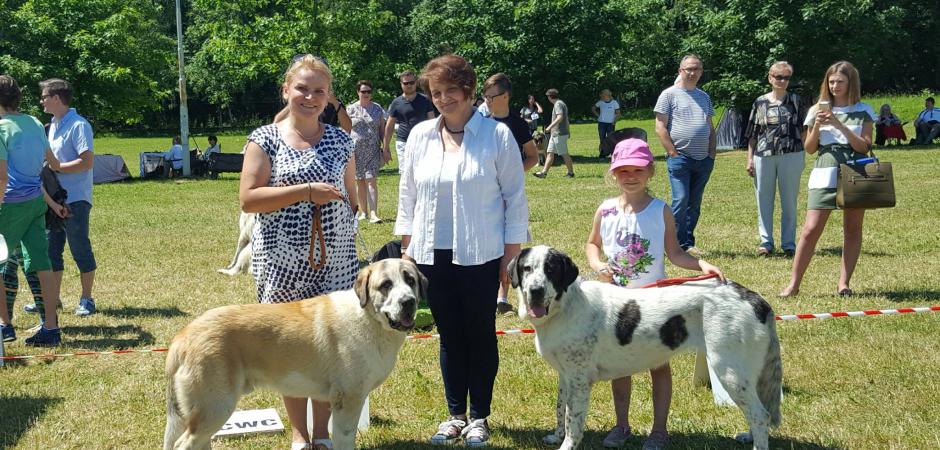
left=780, top=61, right=876, bottom=297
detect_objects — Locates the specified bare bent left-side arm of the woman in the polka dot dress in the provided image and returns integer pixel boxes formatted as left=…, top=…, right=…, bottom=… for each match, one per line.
left=238, top=141, right=344, bottom=213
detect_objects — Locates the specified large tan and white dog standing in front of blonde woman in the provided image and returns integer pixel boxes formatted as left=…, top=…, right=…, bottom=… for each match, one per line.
left=163, top=259, right=427, bottom=450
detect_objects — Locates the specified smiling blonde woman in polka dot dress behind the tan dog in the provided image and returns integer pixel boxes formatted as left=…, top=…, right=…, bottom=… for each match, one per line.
left=239, top=55, right=359, bottom=450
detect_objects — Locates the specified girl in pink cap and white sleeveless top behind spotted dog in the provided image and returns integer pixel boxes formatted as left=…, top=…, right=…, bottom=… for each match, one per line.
left=584, top=139, right=724, bottom=450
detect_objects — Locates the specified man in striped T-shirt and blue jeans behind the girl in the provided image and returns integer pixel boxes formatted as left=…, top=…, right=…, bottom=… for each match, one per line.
left=653, top=54, right=718, bottom=254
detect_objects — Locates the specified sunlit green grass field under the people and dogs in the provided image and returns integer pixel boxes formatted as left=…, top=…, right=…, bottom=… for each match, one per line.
left=0, top=93, right=940, bottom=449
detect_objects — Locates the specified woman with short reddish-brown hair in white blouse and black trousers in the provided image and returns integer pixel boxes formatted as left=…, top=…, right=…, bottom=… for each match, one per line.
left=395, top=55, right=529, bottom=446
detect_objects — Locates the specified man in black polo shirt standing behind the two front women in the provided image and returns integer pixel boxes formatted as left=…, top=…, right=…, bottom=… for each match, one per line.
left=384, top=70, right=434, bottom=174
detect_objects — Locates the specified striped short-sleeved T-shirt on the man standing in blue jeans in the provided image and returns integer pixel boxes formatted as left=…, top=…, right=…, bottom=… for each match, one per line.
left=653, top=86, right=715, bottom=160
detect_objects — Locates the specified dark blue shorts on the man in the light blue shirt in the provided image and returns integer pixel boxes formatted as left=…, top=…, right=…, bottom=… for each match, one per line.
left=46, top=200, right=98, bottom=273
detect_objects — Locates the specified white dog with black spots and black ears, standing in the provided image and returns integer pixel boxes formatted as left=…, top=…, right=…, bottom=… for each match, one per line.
left=509, top=246, right=783, bottom=450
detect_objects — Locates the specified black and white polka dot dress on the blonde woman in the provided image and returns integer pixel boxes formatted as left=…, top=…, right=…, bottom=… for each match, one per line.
left=248, top=124, right=359, bottom=303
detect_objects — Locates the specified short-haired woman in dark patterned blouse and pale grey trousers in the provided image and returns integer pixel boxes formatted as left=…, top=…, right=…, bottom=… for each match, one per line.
left=744, top=61, right=806, bottom=257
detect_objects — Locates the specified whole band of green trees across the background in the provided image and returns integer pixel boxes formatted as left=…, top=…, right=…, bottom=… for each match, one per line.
left=0, top=0, right=940, bottom=127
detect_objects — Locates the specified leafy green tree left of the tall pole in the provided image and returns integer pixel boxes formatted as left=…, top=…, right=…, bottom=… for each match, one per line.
left=0, top=0, right=176, bottom=124
